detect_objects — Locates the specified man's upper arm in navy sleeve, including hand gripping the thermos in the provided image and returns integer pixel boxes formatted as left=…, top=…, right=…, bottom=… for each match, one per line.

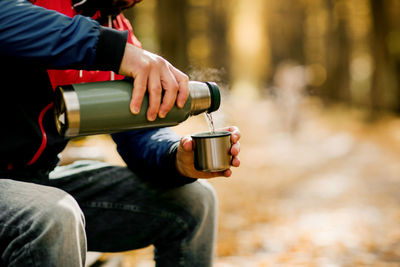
left=0, top=0, right=189, bottom=121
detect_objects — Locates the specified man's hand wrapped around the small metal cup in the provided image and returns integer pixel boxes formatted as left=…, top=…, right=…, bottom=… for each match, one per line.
left=176, top=126, right=240, bottom=179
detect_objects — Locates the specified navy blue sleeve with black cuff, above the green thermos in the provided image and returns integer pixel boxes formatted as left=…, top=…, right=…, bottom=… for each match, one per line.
left=0, top=0, right=127, bottom=71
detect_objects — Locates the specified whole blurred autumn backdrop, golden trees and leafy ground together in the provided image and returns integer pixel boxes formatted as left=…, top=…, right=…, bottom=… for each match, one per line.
left=77, top=0, right=400, bottom=267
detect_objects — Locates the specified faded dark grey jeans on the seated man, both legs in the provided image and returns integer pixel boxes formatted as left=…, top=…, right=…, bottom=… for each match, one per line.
left=0, top=161, right=217, bottom=267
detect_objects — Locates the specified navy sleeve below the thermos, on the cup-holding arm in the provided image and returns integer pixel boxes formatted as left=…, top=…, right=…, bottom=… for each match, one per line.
left=112, top=128, right=196, bottom=186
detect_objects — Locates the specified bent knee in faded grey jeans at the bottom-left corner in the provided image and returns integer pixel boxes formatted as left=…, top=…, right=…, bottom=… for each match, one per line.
left=0, top=178, right=86, bottom=266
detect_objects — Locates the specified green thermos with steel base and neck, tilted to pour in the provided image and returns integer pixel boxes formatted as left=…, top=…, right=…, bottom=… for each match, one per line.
left=55, top=80, right=221, bottom=137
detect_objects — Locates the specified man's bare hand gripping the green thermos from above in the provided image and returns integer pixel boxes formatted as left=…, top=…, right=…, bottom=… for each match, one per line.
left=118, top=43, right=189, bottom=121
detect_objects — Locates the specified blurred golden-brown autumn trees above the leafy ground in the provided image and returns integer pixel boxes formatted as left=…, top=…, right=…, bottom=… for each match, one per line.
left=127, top=0, right=400, bottom=112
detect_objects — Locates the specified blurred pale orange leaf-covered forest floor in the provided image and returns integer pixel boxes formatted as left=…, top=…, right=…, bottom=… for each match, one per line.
left=67, top=96, right=400, bottom=267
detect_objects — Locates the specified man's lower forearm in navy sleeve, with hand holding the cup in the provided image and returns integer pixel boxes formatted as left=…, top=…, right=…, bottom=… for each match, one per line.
left=112, top=126, right=241, bottom=184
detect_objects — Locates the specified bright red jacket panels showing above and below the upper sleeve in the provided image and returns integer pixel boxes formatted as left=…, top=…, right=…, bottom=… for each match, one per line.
left=34, top=0, right=141, bottom=88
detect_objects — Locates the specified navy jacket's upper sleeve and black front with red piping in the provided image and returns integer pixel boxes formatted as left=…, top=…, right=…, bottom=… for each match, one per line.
left=0, top=0, right=128, bottom=170
